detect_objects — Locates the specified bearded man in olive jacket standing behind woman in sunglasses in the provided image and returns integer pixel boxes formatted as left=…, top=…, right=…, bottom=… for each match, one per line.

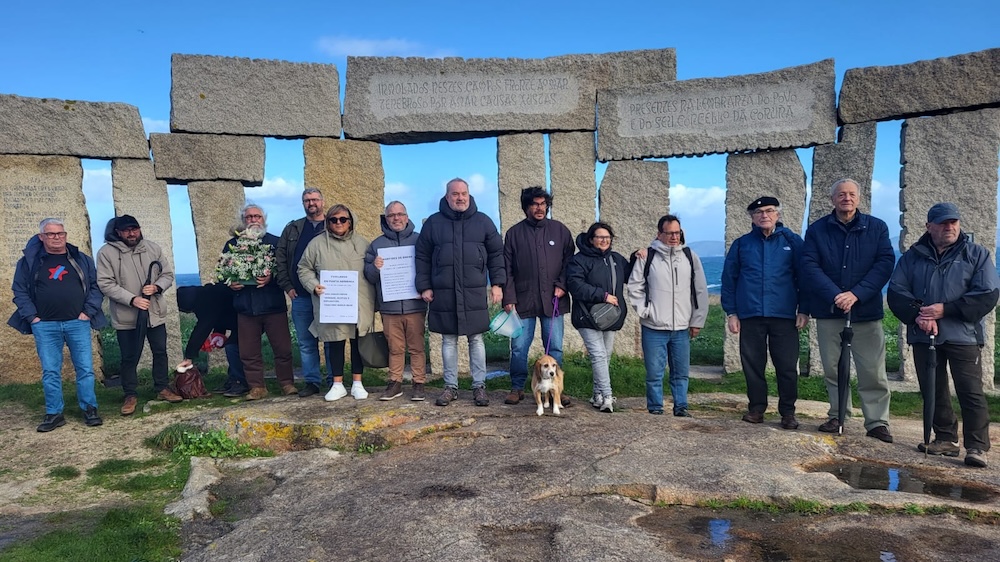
left=274, top=187, right=333, bottom=398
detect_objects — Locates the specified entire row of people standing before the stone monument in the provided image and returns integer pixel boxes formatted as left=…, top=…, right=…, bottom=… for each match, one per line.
left=9, top=178, right=1000, bottom=466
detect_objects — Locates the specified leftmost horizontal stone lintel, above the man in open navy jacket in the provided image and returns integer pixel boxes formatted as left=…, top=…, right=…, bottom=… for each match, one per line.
left=0, top=94, right=149, bottom=160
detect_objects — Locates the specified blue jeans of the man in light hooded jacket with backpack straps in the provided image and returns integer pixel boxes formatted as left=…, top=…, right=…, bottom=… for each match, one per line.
left=642, top=326, right=691, bottom=414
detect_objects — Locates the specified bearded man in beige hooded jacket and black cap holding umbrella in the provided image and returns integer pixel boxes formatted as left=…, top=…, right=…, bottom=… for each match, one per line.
left=97, top=215, right=183, bottom=416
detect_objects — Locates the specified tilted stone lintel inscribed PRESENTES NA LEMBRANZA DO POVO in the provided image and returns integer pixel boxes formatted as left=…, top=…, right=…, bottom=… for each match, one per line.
left=597, top=59, right=837, bottom=161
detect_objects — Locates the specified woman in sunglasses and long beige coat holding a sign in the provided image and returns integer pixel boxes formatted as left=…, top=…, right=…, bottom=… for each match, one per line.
left=298, top=205, right=375, bottom=401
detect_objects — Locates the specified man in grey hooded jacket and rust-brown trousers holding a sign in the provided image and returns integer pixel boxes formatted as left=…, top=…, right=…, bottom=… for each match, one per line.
left=365, top=201, right=427, bottom=401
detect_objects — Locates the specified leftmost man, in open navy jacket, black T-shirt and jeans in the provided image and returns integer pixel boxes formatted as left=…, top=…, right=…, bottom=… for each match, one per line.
left=7, top=218, right=108, bottom=433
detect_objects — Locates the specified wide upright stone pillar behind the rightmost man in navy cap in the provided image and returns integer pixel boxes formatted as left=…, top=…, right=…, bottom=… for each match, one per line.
left=899, top=109, right=1000, bottom=389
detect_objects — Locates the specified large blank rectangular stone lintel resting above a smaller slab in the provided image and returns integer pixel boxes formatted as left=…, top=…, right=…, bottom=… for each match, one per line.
left=170, top=54, right=340, bottom=138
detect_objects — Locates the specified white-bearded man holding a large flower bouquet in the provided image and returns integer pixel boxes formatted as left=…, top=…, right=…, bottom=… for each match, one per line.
left=216, top=203, right=298, bottom=400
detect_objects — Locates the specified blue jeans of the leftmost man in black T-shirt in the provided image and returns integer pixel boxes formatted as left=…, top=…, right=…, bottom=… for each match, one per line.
left=31, top=320, right=97, bottom=414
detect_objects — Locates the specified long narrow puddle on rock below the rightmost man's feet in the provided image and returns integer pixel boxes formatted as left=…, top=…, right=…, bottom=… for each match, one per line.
left=812, top=461, right=998, bottom=500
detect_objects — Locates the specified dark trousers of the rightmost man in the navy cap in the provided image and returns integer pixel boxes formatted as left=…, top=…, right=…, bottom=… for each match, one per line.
left=913, top=343, right=990, bottom=451
